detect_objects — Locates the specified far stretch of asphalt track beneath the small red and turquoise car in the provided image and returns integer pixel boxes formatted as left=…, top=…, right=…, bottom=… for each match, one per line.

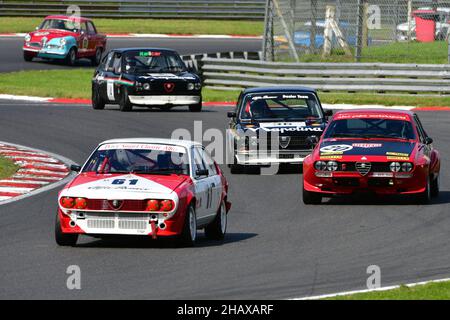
left=0, top=37, right=262, bottom=72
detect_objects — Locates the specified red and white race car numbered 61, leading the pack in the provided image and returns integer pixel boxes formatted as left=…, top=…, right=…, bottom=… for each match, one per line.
left=55, top=138, right=231, bottom=246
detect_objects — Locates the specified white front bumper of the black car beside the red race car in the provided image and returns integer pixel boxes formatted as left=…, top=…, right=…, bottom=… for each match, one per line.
left=235, top=150, right=311, bottom=165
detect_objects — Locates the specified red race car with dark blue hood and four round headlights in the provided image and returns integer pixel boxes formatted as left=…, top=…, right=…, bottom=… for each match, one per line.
left=303, top=109, right=440, bottom=204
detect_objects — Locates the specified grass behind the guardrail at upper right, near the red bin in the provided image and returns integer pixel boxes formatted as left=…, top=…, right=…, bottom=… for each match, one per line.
left=296, top=41, right=448, bottom=64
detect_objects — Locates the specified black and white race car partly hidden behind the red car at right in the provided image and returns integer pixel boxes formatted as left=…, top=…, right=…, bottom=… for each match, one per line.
left=227, top=86, right=332, bottom=173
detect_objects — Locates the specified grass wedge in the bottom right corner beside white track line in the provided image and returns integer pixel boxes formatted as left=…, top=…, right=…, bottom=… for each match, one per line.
left=328, top=282, right=450, bottom=300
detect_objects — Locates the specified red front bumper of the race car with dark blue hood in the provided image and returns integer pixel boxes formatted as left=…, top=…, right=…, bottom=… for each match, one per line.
left=304, top=171, right=426, bottom=196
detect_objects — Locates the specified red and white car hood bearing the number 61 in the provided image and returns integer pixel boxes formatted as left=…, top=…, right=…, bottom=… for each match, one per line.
left=60, top=173, right=189, bottom=200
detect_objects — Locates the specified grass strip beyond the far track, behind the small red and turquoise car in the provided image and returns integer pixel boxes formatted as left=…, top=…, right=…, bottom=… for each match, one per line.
left=0, top=17, right=264, bottom=35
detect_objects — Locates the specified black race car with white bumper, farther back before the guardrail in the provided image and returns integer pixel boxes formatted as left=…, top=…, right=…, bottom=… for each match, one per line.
left=92, top=48, right=202, bottom=112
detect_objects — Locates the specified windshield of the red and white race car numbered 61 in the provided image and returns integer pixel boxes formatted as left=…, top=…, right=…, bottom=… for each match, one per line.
left=83, top=143, right=189, bottom=175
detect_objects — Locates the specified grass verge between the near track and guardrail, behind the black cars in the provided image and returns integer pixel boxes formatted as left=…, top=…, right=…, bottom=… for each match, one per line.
left=0, top=68, right=450, bottom=107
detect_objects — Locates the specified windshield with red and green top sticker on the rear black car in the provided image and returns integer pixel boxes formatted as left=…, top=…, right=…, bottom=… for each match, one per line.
left=123, top=50, right=186, bottom=73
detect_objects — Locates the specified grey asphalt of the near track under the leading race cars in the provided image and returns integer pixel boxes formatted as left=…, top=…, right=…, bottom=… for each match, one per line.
left=0, top=100, right=450, bottom=299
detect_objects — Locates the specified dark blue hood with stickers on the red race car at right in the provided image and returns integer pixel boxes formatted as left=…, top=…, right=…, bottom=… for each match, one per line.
left=319, top=139, right=416, bottom=158
